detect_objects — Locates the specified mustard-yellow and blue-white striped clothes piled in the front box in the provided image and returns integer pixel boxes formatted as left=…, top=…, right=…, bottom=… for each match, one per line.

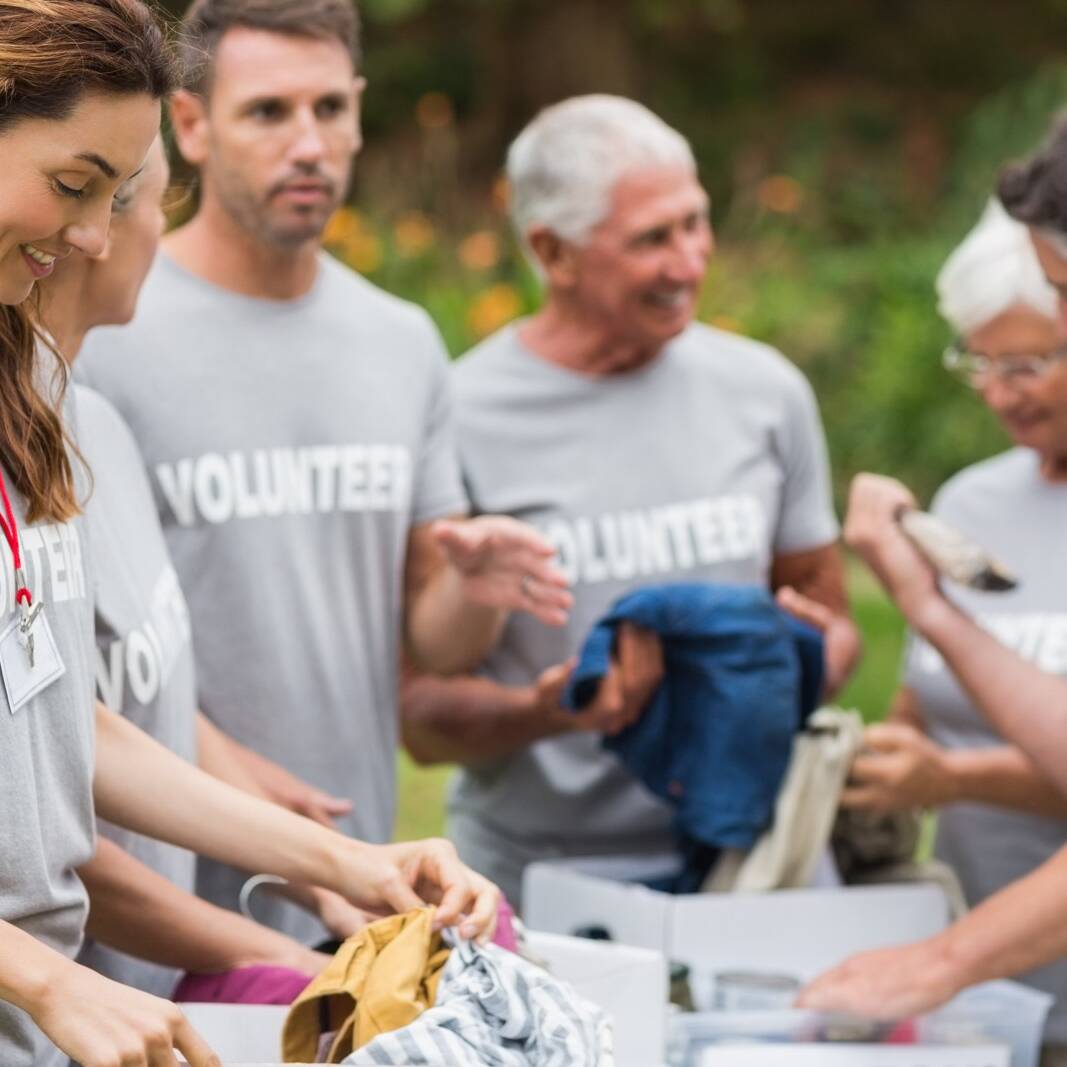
left=282, top=908, right=615, bottom=1067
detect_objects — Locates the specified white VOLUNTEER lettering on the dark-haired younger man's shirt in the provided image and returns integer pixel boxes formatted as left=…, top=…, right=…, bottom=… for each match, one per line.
left=156, top=445, right=412, bottom=526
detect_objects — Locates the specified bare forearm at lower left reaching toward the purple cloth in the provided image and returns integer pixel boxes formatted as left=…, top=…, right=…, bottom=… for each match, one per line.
left=78, top=837, right=319, bottom=973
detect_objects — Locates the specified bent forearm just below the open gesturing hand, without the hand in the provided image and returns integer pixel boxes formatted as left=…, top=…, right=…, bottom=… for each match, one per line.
left=405, top=567, right=507, bottom=674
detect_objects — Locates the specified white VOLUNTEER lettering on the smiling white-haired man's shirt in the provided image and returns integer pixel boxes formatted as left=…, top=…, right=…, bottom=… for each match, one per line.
left=539, top=494, right=767, bottom=584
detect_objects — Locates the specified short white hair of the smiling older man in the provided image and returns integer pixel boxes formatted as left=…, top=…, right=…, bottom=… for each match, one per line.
left=507, top=94, right=697, bottom=244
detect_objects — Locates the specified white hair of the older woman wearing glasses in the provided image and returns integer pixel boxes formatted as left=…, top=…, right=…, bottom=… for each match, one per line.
left=937, top=200, right=1056, bottom=337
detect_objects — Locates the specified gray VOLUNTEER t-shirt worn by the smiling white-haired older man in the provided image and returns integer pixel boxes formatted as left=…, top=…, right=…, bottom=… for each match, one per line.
left=450, top=324, right=838, bottom=894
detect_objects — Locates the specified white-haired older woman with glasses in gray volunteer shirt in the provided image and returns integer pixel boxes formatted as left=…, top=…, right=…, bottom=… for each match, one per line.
left=845, top=203, right=1067, bottom=1065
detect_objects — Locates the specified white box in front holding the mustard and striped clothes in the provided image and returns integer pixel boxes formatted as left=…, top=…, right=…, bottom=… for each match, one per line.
left=181, top=933, right=667, bottom=1067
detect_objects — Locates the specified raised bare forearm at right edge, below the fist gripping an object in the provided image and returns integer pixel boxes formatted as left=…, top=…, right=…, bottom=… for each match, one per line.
left=905, top=598, right=1067, bottom=795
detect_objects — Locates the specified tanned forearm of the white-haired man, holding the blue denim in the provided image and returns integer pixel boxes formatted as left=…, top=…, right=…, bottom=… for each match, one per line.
left=401, top=674, right=567, bottom=764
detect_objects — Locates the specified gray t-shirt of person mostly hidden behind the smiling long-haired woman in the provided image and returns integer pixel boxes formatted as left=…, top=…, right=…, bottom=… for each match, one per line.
left=75, top=385, right=196, bottom=997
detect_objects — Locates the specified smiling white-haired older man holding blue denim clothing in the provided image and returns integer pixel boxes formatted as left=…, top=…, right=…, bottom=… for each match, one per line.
left=403, top=96, right=859, bottom=897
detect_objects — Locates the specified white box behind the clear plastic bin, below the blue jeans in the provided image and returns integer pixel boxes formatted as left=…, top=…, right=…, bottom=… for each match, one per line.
left=523, top=857, right=949, bottom=980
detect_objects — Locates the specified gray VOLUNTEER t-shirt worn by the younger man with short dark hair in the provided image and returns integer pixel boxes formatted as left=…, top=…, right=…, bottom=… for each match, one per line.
left=78, top=254, right=466, bottom=937
